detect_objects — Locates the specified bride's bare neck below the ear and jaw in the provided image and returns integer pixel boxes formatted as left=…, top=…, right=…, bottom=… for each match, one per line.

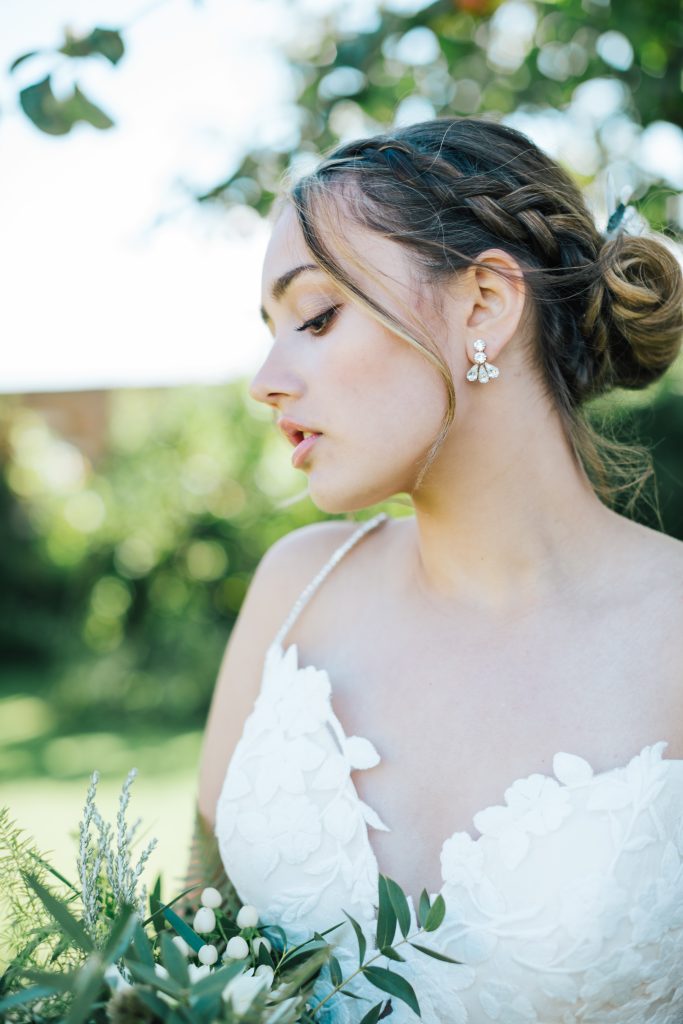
left=413, top=391, right=623, bottom=615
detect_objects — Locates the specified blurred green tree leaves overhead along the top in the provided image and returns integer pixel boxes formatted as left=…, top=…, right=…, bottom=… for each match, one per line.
left=10, top=0, right=683, bottom=241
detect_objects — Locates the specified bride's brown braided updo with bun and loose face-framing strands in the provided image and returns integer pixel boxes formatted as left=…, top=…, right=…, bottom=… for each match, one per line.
left=284, top=117, right=683, bottom=512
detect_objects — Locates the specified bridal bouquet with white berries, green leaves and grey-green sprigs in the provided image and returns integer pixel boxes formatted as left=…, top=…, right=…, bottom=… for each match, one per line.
left=0, top=769, right=459, bottom=1024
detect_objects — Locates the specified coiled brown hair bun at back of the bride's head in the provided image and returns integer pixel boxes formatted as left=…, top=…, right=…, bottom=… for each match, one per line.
left=600, top=233, right=683, bottom=388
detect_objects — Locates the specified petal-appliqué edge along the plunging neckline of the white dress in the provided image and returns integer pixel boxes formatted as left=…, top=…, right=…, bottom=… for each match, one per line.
left=265, top=637, right=683, bottom=903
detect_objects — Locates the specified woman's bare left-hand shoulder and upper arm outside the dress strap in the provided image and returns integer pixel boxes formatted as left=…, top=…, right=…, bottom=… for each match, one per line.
left=198, top=519, right=358, bottom=826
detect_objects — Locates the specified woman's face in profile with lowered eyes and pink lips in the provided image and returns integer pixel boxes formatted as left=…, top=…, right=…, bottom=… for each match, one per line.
left=250, top=199, right=454, bottom=513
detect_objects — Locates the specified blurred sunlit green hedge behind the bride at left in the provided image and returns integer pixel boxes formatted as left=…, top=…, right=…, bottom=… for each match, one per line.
left=0, top=381, right=352, bottom=749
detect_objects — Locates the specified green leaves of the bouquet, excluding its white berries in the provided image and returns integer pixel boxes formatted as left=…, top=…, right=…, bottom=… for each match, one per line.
left=0, top=815, right=458, bottom=1024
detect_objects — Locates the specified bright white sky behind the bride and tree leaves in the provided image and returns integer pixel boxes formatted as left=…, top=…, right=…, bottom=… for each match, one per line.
left=0, top=0, right=683, bottom=393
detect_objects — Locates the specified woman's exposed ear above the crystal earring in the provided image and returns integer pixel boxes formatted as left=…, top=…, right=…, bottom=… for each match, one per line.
left=459, top=249, right=526, bottom=362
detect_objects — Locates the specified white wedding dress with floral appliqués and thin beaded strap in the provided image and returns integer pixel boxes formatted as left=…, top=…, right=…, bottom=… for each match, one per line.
left=215, top=513, right=683, bottom=1024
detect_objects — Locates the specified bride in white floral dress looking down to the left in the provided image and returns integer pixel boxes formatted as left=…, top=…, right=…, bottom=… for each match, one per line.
left=187, top=118, right=683, bottom=1024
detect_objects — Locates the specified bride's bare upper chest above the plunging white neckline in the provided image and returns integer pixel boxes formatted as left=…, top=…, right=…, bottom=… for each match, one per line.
left=288, top=544, right=683, bottom=895
